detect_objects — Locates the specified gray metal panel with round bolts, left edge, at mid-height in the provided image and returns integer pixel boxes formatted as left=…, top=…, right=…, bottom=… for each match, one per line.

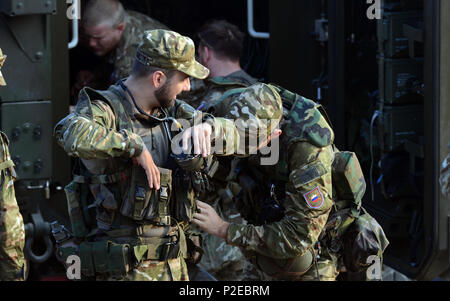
left=1, top=101, right=53, bottom=180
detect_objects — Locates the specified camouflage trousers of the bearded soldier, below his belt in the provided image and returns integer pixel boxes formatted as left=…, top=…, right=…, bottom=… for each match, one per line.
left=96, top=257, right=189, bottom=281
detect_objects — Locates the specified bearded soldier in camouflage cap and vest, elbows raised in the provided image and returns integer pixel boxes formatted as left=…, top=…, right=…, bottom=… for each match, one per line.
left=55, top=30, right=278, bottom=280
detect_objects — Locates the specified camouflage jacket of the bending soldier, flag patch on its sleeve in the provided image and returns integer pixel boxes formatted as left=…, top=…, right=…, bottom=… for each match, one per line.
left=226, top=92, right=334, bottom=259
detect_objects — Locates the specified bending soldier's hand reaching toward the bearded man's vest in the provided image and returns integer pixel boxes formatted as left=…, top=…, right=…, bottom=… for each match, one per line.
left=193, top=201, right=230, bottom=239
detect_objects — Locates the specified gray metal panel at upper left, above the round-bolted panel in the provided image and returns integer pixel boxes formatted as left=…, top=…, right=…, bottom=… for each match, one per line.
left=0, top=15, right=52, bottom=102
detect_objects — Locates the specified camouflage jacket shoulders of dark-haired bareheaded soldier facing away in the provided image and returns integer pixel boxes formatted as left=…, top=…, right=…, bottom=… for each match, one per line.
left=181, top=70, right=257, bottom=110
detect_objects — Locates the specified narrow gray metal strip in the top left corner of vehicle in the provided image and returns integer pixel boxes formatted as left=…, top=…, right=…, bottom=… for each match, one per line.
left=0, top=0, right=56, bottom=17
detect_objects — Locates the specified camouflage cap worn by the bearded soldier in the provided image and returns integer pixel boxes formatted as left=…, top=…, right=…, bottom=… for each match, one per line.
left=136, top=29, right=209, bottom=79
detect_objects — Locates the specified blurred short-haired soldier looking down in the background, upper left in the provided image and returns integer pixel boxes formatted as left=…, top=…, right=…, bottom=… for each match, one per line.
left=72, top=0, right=168, bottom=94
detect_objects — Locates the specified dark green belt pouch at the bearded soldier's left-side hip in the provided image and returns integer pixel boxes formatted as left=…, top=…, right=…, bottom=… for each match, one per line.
left=80, top=240, right=134, bottom=277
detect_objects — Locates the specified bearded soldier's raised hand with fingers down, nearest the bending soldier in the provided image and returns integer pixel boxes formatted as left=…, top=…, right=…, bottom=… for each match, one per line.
left=183, top=123, right=212, bottom=158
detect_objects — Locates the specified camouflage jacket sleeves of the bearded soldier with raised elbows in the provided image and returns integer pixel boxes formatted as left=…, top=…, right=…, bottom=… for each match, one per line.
left=55, top=86, right=239, bottom=160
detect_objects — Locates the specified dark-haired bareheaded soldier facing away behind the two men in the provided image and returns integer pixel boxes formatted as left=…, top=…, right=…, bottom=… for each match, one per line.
left=181, top=20, right=257, bottom=281
